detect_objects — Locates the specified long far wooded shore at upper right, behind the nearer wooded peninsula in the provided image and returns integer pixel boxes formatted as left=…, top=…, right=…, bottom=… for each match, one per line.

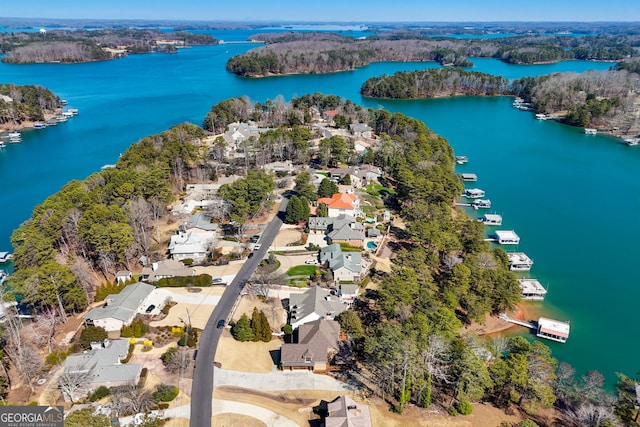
left=227, top=29, right=640, bottom=77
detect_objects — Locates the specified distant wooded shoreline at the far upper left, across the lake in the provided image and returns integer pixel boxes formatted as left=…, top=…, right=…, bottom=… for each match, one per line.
left=0, top=29, right=217, bottom=64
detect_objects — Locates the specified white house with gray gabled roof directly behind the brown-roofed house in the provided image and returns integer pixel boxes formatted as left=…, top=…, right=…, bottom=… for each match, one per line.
left=289, top=286, right=346, bottom=329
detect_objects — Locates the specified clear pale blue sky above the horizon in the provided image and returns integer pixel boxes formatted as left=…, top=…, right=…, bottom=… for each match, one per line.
left=0, top=0, right=640, bottom=23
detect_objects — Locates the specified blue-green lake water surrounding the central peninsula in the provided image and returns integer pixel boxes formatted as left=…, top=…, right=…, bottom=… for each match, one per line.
left=0, top=31, right=640, bottom=381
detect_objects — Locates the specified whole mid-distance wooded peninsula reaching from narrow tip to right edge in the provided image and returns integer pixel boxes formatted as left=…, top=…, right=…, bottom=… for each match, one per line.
left=360, top=67, right=640, bottom=136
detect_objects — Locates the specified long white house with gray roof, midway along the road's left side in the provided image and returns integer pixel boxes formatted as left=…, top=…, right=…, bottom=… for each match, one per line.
left=84, top=282, right=156, bottom=332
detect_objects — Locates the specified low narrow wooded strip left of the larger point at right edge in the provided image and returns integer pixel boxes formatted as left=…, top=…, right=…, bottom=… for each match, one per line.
left=360, top=68, right=509, bottom=99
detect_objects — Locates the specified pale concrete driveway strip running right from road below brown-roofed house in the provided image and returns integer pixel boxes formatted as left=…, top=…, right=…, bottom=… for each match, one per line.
left=213, top=368, right=355, bottom=391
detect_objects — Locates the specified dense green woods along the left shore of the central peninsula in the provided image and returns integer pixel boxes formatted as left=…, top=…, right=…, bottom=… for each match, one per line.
left=10, top=124, right=204, bottom=311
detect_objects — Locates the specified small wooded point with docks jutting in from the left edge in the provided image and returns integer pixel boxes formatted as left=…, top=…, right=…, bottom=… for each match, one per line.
left=0, top=84, right=62, bottom=126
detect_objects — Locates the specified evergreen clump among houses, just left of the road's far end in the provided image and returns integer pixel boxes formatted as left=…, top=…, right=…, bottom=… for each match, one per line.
left=218, top=170, right=274, bottom=223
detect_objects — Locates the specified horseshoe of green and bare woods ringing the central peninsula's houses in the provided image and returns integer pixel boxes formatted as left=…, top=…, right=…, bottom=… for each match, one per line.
left=9, top=94, right=635, bottom=425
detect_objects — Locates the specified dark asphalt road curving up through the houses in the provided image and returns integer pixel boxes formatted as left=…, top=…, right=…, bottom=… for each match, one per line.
left=189, top=199, right=288, bottom=427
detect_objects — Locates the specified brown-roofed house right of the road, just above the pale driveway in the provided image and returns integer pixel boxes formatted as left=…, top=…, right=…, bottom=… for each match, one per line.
left=280, top=319, right=351, bottom=373
